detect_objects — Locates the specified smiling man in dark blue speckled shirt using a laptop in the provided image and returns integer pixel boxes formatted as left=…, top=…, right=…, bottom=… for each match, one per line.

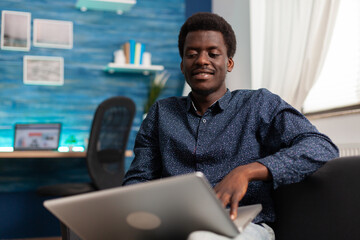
left=124, top=13, right=338, bottom=239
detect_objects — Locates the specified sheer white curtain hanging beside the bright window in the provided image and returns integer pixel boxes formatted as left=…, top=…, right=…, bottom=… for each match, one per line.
left=250, top=0, right=340, bottom=110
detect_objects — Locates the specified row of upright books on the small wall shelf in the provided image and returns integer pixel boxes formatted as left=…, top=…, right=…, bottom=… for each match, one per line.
left=122, top=39, right=145, bottom=65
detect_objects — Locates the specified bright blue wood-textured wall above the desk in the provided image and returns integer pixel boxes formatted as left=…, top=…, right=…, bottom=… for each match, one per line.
left=0, top=0, right=185, bottom=162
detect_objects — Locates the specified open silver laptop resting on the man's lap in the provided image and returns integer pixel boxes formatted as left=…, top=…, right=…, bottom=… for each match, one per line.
left=44, top=172, right=262, bottom=240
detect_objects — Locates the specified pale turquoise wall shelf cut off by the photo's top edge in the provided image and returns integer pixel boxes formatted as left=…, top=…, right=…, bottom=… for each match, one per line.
left=76, top=0, right=136, bottom=14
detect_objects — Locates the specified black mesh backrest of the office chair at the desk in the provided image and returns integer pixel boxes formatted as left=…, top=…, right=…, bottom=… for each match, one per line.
left=87, top=97, right=135, bottom=189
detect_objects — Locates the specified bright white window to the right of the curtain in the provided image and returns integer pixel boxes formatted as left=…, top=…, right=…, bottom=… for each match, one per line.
left=303, top=0, right=360, bottom=113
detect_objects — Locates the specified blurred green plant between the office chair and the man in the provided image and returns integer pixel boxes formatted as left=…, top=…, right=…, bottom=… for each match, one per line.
left=144, top=71, right=170, bottom=114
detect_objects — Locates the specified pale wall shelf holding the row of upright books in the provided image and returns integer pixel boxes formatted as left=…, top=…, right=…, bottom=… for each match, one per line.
left=104, top=63, right=164, bottom=75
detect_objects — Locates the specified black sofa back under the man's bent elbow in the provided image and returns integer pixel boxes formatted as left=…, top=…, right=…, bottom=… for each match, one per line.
left=274, top=156, right=360, bottom=240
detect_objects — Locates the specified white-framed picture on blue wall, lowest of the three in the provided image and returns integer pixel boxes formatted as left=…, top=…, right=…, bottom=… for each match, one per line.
left=23, top=56, right=64, bottom=85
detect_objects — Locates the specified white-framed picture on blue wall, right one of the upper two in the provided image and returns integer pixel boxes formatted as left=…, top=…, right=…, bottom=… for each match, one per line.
left=33, top=19, right=73, bottom=49
